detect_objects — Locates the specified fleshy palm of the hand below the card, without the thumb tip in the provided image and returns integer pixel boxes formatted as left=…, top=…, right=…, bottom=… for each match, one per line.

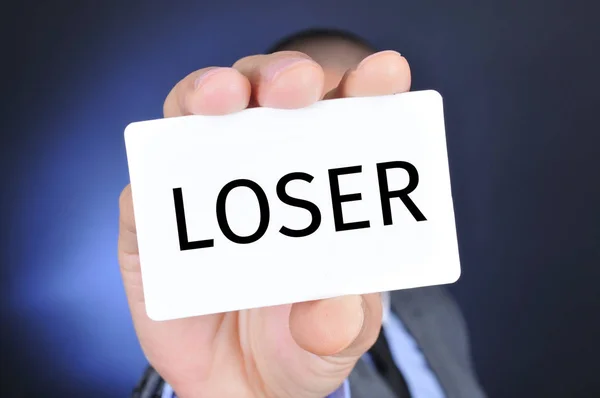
left=128, top=296, right=354, bottom=398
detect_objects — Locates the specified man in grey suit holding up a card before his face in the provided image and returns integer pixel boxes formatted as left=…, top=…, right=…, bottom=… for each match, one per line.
left=119, top=31, right=484, bottom=398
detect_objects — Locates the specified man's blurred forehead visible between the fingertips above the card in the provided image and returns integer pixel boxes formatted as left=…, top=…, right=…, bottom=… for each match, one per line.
left=284, top=38, right=373, bottom=92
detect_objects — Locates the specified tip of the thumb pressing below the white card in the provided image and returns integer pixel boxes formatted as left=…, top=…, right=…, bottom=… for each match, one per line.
left=290, top=293, right=382, bottom=359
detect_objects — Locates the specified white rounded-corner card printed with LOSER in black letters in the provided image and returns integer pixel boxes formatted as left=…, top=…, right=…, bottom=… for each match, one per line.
left=125, top=91, right=460, bottom=320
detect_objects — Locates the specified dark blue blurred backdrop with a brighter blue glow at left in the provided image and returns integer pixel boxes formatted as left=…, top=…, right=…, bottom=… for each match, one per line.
left=0, top=0, right=600, bottom=398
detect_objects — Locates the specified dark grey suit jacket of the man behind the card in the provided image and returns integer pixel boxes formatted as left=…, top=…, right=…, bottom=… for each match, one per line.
left=134, top=286, right=485, bottom=398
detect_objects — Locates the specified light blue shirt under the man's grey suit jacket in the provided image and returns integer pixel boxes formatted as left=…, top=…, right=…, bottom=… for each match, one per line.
left=162, top=293, right=445, bottom=398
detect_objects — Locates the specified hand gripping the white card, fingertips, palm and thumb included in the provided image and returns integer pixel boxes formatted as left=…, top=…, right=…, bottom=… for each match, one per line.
left=119, top=51, right=410, bottom=398
